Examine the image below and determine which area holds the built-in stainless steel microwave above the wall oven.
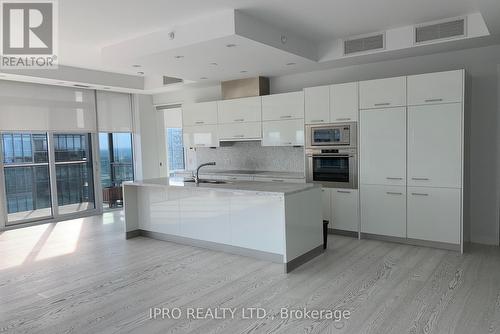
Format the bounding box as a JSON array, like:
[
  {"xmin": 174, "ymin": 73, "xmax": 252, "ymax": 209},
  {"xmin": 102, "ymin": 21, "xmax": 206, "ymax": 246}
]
[{"xmin": 306, "ymin": 122, "xmax": 357, "ymax": 148}]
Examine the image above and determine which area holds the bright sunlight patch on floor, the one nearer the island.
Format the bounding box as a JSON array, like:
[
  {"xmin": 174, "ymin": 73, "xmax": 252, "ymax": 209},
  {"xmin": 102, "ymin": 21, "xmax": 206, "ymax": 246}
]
[{"xmin": 35, "ymin": 218, "xmax": 84, "ymax": 261}]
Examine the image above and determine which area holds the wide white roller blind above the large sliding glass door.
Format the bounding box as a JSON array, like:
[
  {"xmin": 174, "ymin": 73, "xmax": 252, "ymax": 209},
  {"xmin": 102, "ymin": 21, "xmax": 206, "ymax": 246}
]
[{"xmin": 0, "ymin": 80, "xmax": 96, "ymax": 132}]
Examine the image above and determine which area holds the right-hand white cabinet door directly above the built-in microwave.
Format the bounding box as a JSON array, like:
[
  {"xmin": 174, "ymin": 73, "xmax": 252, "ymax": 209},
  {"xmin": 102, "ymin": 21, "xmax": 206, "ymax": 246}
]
[{"xmin": 330, "ymin": 82, "xmax": 359, "ymax": 122}]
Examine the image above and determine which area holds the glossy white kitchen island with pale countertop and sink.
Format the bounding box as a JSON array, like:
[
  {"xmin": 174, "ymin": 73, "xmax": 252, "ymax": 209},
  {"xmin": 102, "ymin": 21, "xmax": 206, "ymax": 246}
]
[{"xmin": 124, "ymin": 177, "xmax": 323, "ymax": 272}]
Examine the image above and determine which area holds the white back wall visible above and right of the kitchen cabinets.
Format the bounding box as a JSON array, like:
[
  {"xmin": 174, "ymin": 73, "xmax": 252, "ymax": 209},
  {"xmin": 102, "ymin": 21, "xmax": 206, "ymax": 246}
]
[{"xmin": 154, "ymin": 45, "xmax": 500, "ymax": 245}]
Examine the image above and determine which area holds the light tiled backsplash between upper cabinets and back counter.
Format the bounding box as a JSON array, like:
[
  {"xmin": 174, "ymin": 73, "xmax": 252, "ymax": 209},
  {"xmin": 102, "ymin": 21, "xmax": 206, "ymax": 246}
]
[{"xmin": 187, "ymin": 142, "xmax": 304, "ymax": 172}]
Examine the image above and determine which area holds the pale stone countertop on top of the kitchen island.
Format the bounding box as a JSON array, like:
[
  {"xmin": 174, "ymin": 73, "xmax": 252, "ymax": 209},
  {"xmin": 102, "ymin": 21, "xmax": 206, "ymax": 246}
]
[{"xmin": 124, "ymin": 177, "xmax": 319, "ymax": 195}]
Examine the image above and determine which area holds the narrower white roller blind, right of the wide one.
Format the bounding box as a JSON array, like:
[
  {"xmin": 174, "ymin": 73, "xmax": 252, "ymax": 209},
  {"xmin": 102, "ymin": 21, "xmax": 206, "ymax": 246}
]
[{"xmin": 97, "ymin": 91, "xmax": 132, "ymax": 132}]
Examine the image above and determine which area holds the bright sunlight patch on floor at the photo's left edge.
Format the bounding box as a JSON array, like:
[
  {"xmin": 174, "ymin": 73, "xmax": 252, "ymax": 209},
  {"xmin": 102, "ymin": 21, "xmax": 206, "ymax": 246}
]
[{"xmin": 0, "ymin": 224, "xmax": 49, "ymax": 270}]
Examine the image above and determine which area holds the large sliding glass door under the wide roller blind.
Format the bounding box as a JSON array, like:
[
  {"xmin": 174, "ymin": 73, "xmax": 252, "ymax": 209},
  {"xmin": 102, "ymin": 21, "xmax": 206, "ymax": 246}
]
[{"xmin": 0, "ymin": 132, "xmax": 96, "ymax": 225}]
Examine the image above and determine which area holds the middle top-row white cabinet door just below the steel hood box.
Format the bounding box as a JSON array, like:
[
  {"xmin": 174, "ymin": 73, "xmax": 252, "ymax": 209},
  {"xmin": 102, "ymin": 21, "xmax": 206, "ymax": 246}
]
[{"xmin": 218, "ymin": 96, "xmax": 262, "ymax": 123}]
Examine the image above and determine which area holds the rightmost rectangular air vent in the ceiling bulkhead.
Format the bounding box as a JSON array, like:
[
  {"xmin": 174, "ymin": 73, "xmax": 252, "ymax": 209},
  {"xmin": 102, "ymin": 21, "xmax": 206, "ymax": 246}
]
[{"xmin": 415, "ymin": 18, "xmax": 465, "ymax": 44}]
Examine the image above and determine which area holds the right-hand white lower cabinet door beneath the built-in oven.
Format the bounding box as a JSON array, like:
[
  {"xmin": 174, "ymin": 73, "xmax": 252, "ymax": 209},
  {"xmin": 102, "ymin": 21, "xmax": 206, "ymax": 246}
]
[{"xmin": 330, "ymin": 189, "xmax": 359, "ymax": 232}]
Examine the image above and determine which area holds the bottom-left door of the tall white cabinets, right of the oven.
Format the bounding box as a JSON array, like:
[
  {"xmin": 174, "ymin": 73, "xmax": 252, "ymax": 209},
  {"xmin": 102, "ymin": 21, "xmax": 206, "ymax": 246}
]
[{"xmin": 360, "ymin": 185, "xmax": 406, "ymax": 238}]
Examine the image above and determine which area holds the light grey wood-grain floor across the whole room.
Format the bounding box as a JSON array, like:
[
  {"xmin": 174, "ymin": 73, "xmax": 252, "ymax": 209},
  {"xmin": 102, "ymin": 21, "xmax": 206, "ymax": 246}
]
[{"xmin": 0, "ymin": 212, "xmax": 500, "ymax": 334}]
